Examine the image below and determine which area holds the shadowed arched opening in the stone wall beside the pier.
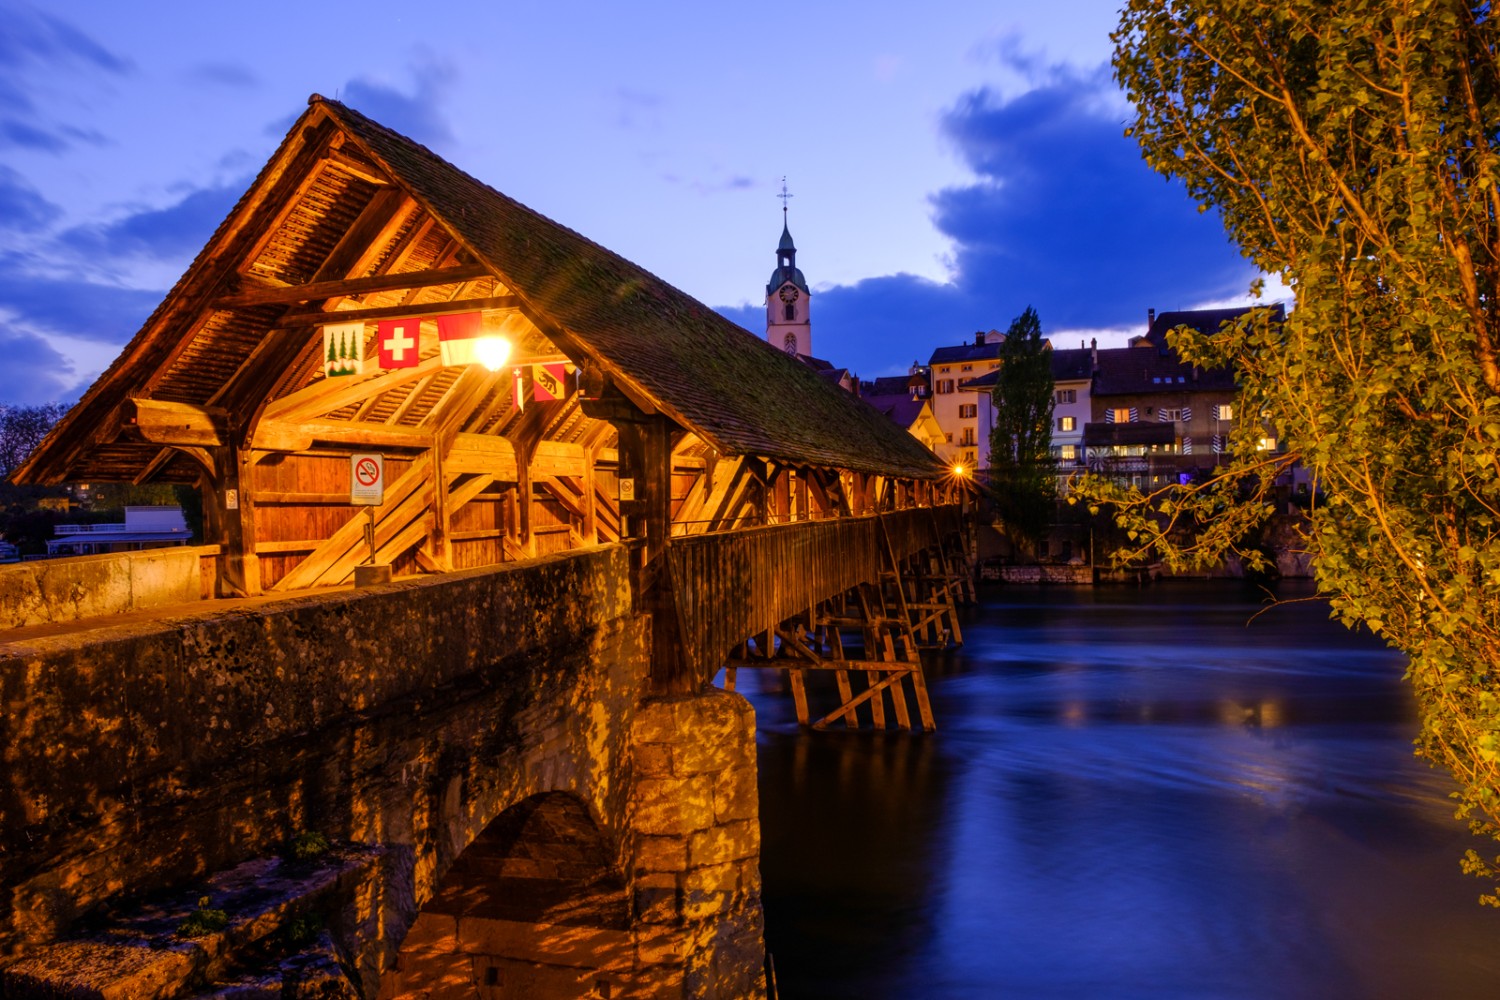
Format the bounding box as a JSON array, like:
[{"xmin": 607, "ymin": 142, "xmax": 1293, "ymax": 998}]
[{"xmin": 380, "ymin": 792, "xmax": 635, "ymax": 1000}]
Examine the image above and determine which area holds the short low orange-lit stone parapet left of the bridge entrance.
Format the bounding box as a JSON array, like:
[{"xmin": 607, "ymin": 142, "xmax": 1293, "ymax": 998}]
[{"xmin": 0, "ymin": 546, "xmax": 216, "ymax": 629}]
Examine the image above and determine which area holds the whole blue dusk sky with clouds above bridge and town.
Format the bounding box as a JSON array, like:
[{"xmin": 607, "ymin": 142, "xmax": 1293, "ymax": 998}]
[{"xmin": 0, "ymin": 0, "xmax": 1272, "ymax": 403}]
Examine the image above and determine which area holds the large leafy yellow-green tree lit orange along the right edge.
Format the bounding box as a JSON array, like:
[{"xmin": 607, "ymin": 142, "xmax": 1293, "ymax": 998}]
[{"xmin": 1116, "ymin": 0, "xmax": 1500, "ymax": 906}]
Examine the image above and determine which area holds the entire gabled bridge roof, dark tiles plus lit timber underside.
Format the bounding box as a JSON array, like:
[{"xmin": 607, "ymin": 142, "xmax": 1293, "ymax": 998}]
[{"xmin": 17, "ymin": 94, "xmax": 944, "ymax": 483}]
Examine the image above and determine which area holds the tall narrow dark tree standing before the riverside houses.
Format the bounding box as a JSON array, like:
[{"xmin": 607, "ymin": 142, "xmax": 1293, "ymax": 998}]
[{"xmin": 990, "ymin": 306, "xmax": 1056, "ymax": 544}]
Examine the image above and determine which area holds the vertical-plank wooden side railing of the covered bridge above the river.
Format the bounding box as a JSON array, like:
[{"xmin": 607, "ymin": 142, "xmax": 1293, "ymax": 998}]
[{"xmin": 666, "ymin": 505, "xmax": 960, "ymax": 678}]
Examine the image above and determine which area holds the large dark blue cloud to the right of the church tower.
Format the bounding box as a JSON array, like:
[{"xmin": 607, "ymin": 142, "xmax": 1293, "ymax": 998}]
[{"xmin": 722, "ymin": 62, "xmax": 1256, "ymax": 375}]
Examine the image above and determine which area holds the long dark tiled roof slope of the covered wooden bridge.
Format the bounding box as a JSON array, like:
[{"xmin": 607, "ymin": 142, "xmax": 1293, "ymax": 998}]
[{"xmin": 322, "ymin": 97, "xmax": 942, "ymax": 478}]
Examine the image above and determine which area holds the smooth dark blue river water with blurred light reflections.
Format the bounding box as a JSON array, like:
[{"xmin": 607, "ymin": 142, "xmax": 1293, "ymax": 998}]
[{"xmin": 741, "ymin": 585, "xmax": 1500, "ymax": 1000}]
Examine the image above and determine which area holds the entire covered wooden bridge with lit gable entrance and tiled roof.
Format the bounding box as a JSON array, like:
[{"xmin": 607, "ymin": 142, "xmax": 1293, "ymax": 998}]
[{"xmin": 17, "ymin": 96, "xmax": 968, "ymax": 726}]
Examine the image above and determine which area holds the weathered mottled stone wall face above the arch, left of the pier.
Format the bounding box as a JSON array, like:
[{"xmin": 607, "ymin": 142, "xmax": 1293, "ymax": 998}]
[{"xmin": 0, "ymin": 546, "xmax": 648, "ymax": 996}]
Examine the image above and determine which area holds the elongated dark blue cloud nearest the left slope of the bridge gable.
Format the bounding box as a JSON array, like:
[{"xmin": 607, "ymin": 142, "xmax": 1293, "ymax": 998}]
[{"xmin": 57, "ymin": 178, "xmax": 249, "ymax": 261}]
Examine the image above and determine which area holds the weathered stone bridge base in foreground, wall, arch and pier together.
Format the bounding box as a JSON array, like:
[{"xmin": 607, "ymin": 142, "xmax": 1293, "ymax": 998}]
[{"xmin": 0, "ymin": 546, "xmax": 765, "ymax": 1000}]
